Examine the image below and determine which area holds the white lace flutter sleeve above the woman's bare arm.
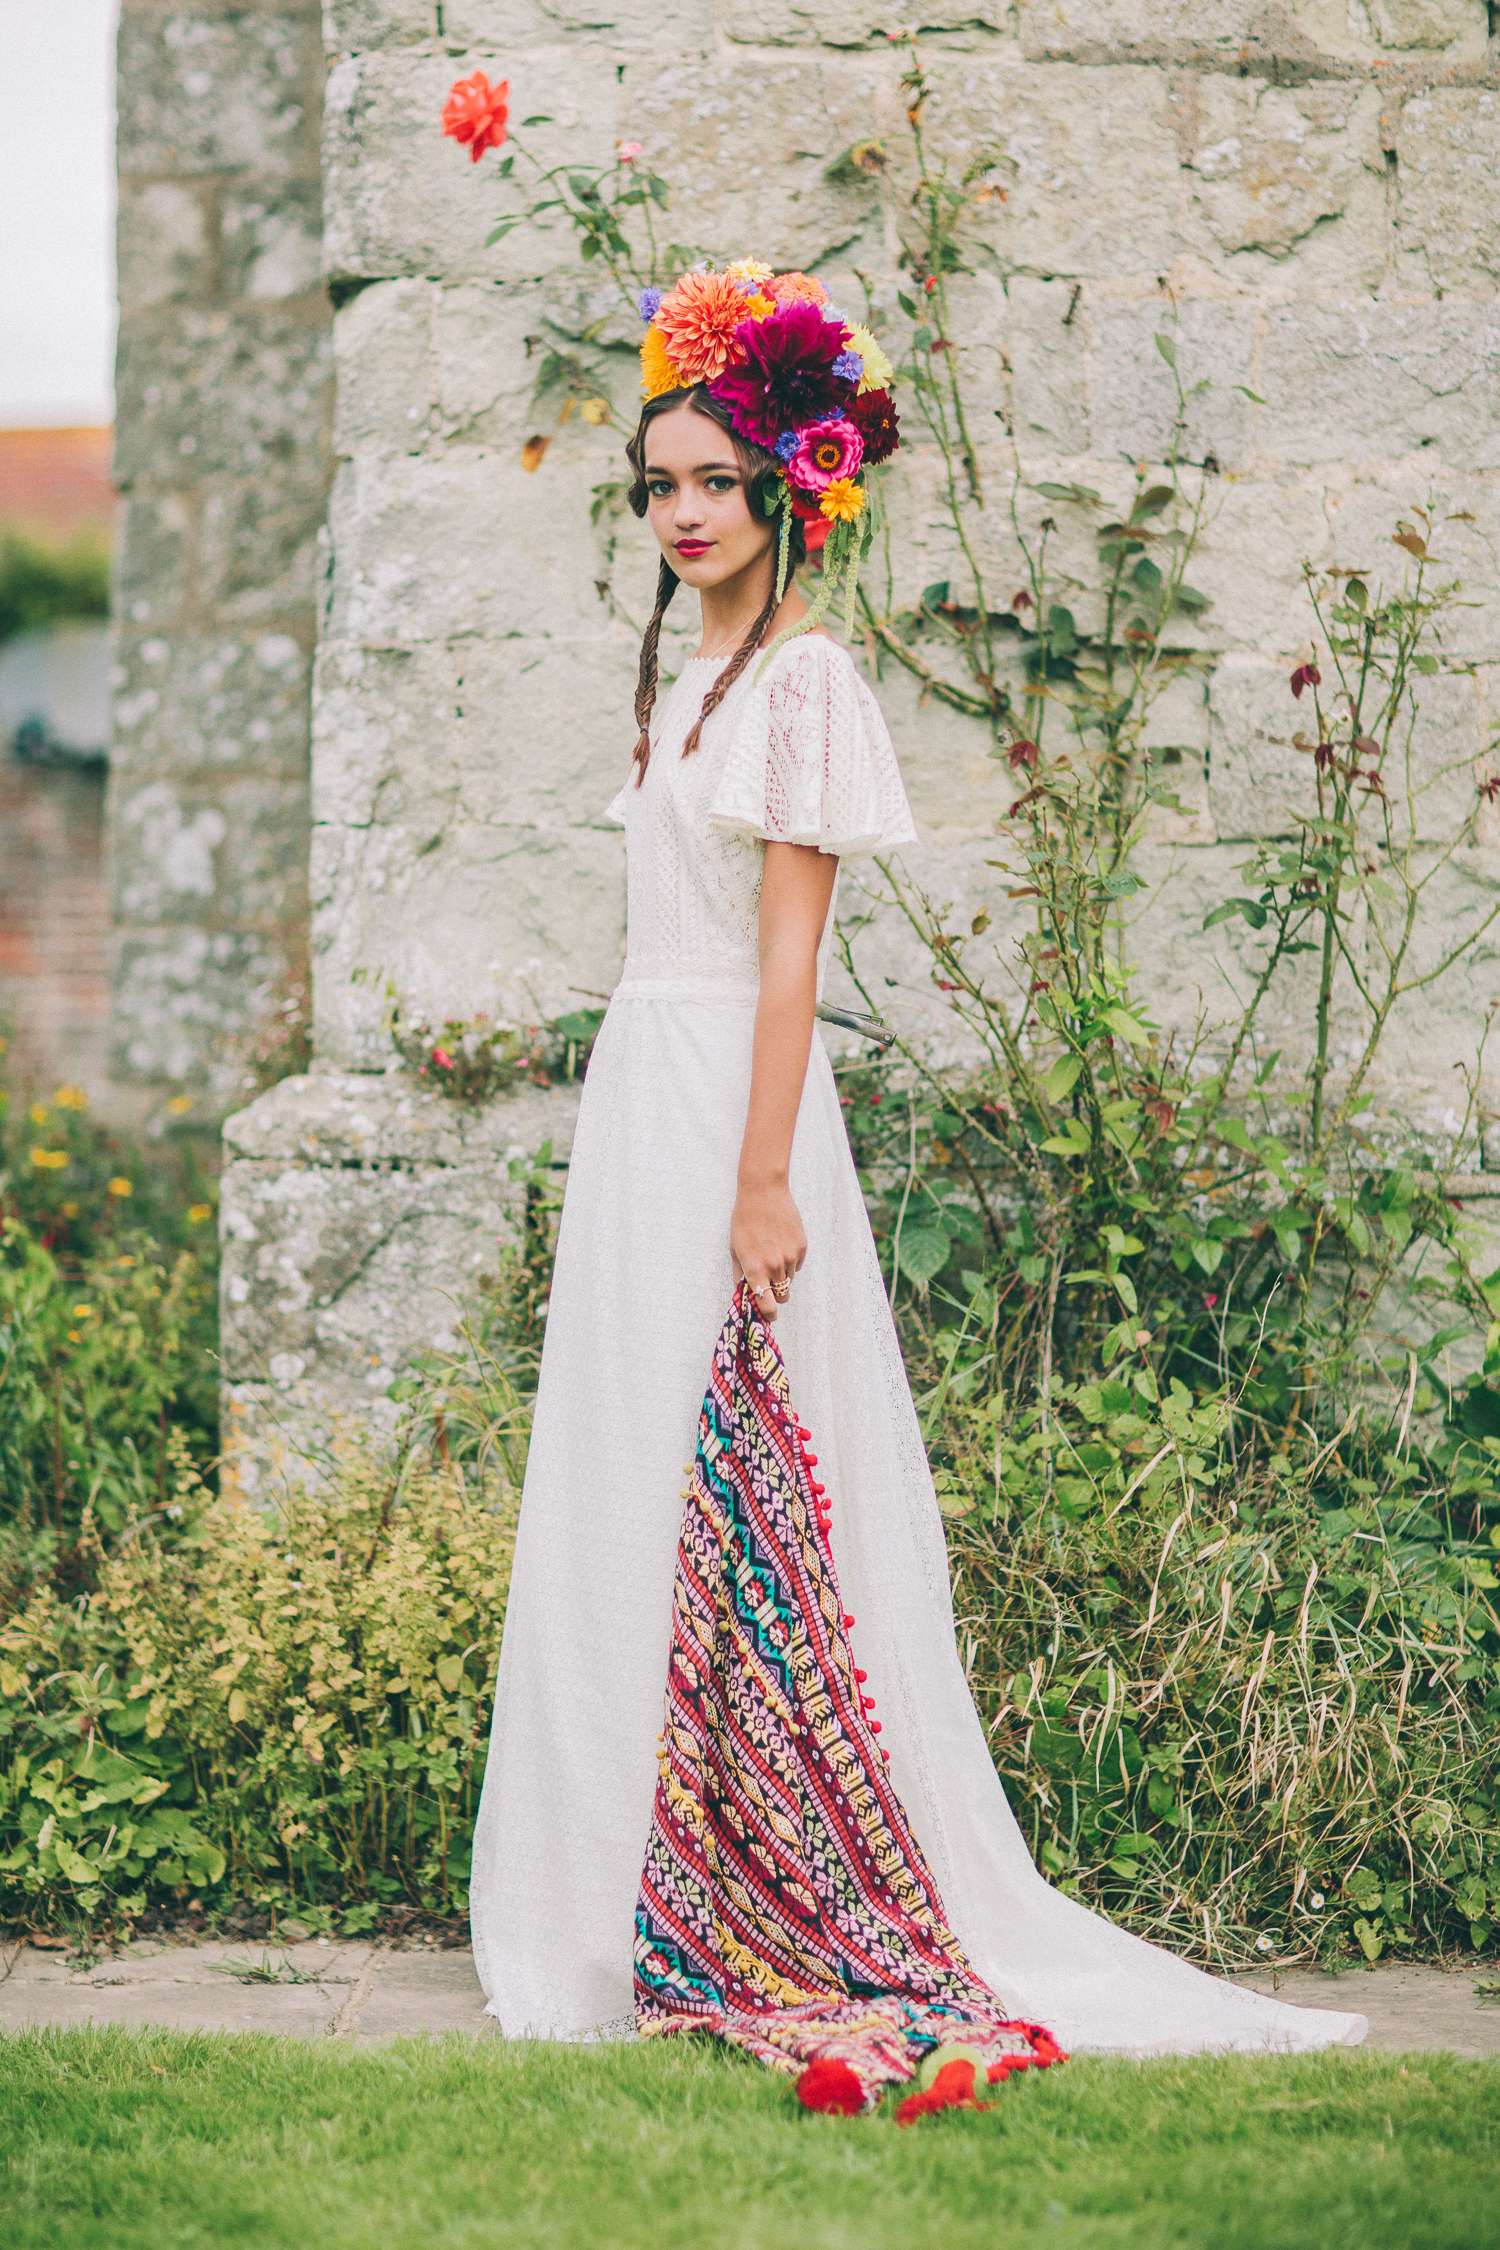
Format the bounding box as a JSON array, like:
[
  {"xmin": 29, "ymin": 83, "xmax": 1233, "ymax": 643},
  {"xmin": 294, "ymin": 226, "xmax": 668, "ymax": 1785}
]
[{"xmin": 708, "ymin": 632, "xmax": 920, "ymax": 855}]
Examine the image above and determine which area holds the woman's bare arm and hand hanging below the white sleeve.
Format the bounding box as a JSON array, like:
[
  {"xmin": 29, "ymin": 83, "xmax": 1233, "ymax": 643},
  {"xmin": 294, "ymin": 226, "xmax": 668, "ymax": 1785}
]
[{"xmin": 729, "ymin": 844, "xmax": 839, "ymax": 1321}]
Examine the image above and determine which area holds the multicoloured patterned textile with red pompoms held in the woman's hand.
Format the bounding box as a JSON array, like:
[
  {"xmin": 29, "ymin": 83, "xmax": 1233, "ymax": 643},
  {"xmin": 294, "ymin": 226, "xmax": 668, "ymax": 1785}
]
[{"xmin": 634, "ymin": 1280, "xmax": 1061, "ymax": 2111}]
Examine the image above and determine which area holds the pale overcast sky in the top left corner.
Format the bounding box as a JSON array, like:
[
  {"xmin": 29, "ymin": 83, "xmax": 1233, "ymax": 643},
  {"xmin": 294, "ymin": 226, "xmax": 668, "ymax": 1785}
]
[{"xmin": 0, "ymin": 0, "xmax": 117, "ymax": 428}]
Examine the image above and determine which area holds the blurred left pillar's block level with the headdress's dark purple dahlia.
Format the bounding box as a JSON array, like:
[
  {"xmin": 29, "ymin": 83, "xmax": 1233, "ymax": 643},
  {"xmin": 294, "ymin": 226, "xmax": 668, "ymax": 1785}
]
[{"xmin": 115, "ymin": 304, "xmax": 333, "ymax": 484}]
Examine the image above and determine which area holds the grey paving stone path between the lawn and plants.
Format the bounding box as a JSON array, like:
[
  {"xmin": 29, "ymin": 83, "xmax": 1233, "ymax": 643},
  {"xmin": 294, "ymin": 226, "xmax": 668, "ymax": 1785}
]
[{"xmin": 0, "ymin": 1937, "xmax": 1500, "ymax": 2057}]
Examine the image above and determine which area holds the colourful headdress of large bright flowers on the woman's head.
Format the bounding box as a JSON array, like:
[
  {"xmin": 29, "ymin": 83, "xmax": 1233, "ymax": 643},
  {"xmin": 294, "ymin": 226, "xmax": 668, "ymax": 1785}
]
[{"xmin": 636, "ymin": 259, "xmax": 900, "ymax": 666}]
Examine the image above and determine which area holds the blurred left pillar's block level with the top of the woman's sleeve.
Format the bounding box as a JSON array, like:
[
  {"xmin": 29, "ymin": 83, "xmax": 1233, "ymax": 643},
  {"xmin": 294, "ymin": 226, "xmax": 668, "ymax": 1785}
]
[{"xmin": 110, "ymin": 632, "xmax": 308, "ymax": 783}]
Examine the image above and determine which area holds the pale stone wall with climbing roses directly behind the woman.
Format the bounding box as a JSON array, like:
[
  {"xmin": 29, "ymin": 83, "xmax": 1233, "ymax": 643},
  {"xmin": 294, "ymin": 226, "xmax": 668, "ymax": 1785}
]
[{"xmin": 225, "ymin": 0, "xmax": 1500, "ymax": 1478}]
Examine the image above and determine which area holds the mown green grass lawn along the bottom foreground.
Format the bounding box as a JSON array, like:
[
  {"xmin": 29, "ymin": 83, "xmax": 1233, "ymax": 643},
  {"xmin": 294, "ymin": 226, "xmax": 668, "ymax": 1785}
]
[{"xmin": 0, "ymin": 2027, "xmax": 1500, "ymax": 2250}]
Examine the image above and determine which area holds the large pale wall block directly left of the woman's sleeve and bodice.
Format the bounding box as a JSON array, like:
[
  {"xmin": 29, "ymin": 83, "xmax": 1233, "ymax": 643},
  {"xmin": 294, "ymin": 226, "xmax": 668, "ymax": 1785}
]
[{"xmin": 313, "ymin": 635, "xmax": 643, "ymax": 835}]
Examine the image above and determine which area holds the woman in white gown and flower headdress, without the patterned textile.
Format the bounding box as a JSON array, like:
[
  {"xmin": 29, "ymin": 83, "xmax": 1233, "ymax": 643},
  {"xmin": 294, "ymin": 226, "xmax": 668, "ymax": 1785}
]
[{"xmin": 470, "ymin": 261, "xmax": 1365, "ymax": 2097}]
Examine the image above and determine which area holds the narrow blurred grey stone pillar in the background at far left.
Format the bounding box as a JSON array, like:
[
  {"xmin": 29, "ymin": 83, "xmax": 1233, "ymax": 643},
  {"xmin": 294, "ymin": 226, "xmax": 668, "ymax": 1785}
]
[{"xmin": 108, "ymin": 0, "xmax": 333, "ymax": 1114}]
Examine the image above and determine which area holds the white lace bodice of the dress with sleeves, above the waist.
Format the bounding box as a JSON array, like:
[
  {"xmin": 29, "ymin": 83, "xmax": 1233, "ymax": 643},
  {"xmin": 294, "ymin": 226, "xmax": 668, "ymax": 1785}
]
[{"xmin": 605, "ymin": 632, "xmax": 918, "ymax": 997}]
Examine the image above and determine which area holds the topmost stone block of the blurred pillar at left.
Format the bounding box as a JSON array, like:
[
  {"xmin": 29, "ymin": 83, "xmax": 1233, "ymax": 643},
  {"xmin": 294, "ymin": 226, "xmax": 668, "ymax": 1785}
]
[{"xmin": 117, "ymin": 5, "xmax": 324, "ymax": 178}]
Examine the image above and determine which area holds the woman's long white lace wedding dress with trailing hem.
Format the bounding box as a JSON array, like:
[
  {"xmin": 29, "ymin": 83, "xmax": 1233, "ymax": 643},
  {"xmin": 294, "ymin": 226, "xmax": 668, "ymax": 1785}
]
[{"xmin": 470, "ymin": 632, "xmax": 1365, "ymax": 2054}]
